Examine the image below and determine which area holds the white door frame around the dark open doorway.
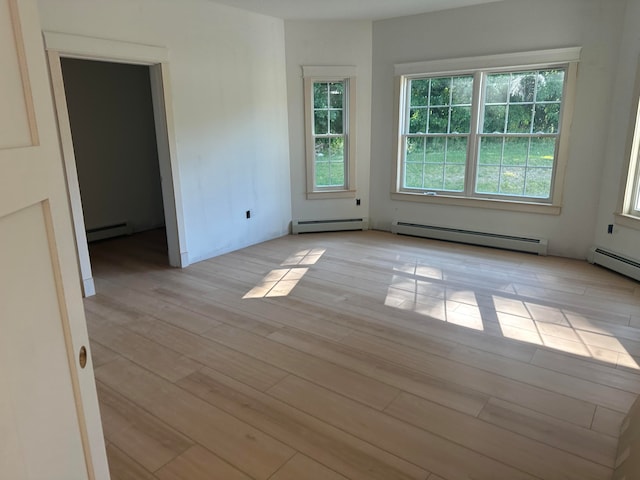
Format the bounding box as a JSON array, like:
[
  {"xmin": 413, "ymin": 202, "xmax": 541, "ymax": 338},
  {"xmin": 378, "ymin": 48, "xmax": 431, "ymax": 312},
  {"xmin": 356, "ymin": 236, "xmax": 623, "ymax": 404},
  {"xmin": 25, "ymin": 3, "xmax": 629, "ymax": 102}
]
[{"xmin": 44, "ymin": 32, "xmax": 189, "ymax": 297}]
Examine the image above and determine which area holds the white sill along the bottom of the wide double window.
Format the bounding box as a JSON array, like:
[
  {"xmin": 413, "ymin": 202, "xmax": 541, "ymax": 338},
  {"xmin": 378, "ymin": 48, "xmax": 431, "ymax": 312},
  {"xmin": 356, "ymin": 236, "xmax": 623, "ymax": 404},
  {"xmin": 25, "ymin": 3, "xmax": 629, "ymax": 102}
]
[{"xmin": 391, "ymin": 192, "xmax": 562, "ymax": 215}]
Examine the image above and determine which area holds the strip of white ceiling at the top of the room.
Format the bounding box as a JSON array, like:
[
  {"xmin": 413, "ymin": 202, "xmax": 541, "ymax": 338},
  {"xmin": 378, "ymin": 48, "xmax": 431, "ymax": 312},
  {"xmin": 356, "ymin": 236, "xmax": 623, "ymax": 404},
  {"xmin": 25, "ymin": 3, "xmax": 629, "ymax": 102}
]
[{"xmin": 208, "ymin": 0, "xmax": 503, "ymax": 20}]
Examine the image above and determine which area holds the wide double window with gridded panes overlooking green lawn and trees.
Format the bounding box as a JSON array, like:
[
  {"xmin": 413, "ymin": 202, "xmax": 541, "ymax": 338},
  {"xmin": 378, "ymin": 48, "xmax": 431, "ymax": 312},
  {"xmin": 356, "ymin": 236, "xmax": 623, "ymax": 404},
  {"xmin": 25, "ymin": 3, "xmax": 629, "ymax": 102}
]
[{"xmin": 394, "ymin": 49, "xmax": 579, "ymax": 213}]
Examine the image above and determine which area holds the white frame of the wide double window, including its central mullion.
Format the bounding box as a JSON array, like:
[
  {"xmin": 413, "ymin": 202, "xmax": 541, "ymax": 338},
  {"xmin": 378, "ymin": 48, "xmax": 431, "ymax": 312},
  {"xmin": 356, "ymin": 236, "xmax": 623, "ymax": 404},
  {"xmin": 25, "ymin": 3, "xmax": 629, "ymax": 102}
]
[{"xmin": 391, "ymin": 47, "xmax": 581, "ymax": 215}]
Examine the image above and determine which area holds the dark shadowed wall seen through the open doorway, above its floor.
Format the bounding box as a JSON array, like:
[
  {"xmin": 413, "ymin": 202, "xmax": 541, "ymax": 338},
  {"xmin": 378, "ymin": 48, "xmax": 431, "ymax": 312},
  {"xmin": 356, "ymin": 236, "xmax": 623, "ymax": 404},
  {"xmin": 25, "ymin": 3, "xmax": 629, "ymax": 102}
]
[{"xmin": 60, "ymin": 58, "xmax": 168, "ymax": 255}]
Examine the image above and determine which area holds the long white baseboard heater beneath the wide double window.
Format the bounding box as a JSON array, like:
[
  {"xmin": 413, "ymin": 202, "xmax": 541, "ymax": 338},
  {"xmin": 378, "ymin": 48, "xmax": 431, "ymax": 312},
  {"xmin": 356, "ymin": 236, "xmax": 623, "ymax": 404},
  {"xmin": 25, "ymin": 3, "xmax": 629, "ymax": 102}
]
[{"xmin": 391, "ymin": 221, "xmax": 547, "ymax": 255}]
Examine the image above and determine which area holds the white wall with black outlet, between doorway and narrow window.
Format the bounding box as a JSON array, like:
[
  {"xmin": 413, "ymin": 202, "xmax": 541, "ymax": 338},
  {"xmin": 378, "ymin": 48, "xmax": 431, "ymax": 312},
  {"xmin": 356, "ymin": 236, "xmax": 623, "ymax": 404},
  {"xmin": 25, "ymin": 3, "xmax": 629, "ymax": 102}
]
[{"xmin": 39, "ymin": 0, "xmax": 291, "ymax": 262}]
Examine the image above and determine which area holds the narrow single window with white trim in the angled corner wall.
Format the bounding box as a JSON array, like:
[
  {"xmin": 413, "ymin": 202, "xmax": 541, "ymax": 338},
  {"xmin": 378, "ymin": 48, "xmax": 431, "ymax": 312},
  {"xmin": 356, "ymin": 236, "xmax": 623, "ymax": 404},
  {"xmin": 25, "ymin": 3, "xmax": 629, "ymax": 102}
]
[{"xmin": 303, "ymin": 67, "xmax": 355, "ymax": 199}]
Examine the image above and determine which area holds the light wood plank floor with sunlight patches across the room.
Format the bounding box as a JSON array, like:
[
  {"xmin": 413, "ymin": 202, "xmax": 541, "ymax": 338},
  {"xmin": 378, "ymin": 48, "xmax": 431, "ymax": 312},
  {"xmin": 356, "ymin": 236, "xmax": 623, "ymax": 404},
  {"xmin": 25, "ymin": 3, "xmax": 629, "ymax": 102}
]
[{"xmin": 85, "ymin": 232, "xmax": 640, "ymax": 480}]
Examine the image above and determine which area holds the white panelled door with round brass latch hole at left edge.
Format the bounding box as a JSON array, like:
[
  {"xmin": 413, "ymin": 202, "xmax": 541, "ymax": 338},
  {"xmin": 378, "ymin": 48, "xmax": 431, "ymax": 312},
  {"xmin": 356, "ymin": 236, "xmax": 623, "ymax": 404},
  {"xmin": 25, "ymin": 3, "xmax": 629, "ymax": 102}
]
[{"xmin": 0, "ymin": 0, "xmax": 109, "ymax": 480}]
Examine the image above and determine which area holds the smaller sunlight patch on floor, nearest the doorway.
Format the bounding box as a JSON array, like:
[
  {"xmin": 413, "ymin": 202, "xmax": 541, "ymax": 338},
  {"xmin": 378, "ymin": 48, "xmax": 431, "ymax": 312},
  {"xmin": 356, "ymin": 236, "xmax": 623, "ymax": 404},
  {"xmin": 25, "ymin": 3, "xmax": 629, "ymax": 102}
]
[{"xmin": 242, "ymin": 248, "xmax": 326, "ymax": 299}]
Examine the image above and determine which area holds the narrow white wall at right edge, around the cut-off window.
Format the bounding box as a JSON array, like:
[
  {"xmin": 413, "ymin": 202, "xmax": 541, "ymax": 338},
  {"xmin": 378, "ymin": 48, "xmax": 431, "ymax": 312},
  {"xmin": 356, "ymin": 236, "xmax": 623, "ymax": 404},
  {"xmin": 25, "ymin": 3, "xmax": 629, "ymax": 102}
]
[{"xmin": 595, "ymin": 0, "xmax": 640, "ymax": 259}]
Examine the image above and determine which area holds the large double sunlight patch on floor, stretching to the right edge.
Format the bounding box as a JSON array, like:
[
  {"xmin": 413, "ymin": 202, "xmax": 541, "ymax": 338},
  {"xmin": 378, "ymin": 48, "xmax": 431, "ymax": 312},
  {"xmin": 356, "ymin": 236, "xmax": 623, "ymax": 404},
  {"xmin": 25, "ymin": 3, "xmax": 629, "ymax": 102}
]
[{"xmin": 384, "ymin": 272, "xmax": 640, "ymax": 369}]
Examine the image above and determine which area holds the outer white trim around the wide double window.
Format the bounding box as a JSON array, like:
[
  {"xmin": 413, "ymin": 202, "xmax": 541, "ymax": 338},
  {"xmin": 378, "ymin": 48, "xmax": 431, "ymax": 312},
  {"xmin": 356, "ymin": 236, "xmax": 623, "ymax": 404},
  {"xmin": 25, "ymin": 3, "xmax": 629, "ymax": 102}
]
[{"xmin": 391, "ymin": 47, "xmax": 582, "ymax": 215}]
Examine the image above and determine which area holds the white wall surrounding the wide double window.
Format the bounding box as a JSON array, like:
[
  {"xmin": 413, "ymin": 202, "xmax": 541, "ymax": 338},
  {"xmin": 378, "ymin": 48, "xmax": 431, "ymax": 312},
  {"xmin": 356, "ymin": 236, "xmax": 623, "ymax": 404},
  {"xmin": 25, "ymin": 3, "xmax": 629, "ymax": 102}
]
[{"xmin": 371, "ymin": 0, "xmax": 624, "ymax": 258}]
